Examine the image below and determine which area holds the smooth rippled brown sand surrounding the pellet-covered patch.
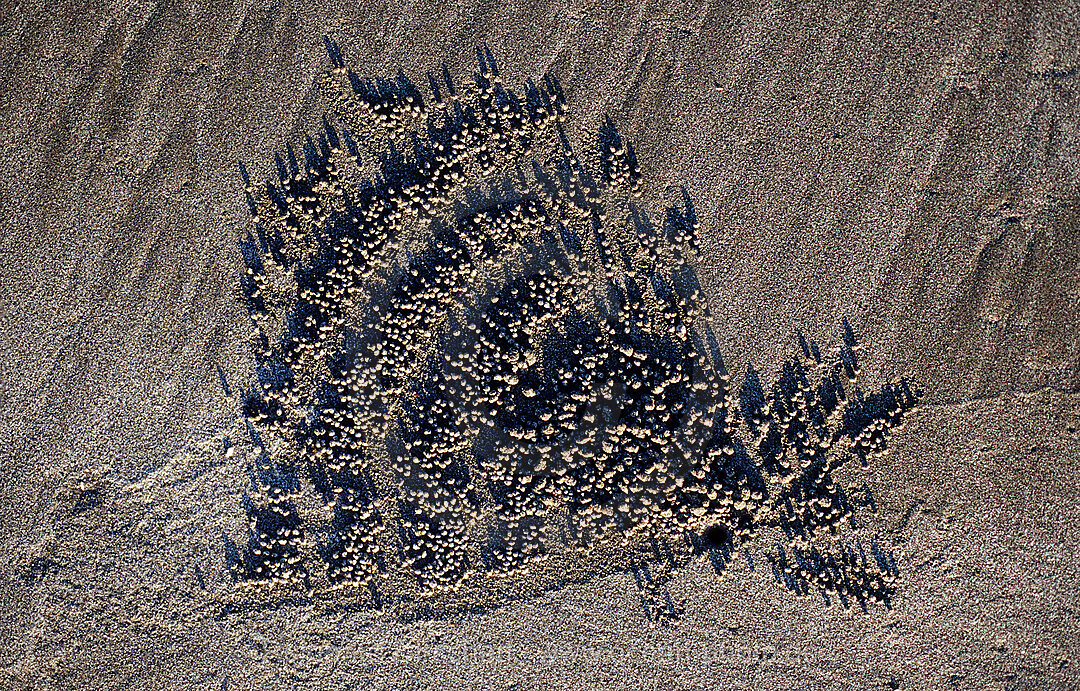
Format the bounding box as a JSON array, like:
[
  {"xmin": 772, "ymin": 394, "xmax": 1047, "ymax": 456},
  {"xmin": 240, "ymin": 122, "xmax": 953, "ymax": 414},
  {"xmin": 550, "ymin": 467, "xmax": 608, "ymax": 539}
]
[{"xmin": 0, "ymin": 1, "xmax": 1080, "ymax": 689}]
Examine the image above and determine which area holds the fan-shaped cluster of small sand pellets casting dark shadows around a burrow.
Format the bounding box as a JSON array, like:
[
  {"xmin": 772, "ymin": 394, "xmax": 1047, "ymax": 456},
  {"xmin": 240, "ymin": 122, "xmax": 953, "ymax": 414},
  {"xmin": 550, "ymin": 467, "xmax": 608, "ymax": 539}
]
[{"xmin": 227, "ymin": 41, "xmax": 918, "ymax": 619}]
